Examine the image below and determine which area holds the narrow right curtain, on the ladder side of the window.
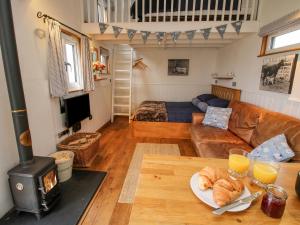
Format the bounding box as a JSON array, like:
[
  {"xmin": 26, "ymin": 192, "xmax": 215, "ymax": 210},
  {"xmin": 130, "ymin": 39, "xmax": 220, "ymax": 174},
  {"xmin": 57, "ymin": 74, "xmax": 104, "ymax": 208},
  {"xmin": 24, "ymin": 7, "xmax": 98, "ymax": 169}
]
[{"xmin": 80, "ymin": 36, "xmax": 95, "ymax": 91}]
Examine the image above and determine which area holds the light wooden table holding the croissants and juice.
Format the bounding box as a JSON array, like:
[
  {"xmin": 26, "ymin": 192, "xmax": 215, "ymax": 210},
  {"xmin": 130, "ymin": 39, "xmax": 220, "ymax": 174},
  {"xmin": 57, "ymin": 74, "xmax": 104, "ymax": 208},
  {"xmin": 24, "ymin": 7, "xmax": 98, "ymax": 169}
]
[{"xmin": 129, "ymin": 155, "xmax": 300, "ymax": 225}]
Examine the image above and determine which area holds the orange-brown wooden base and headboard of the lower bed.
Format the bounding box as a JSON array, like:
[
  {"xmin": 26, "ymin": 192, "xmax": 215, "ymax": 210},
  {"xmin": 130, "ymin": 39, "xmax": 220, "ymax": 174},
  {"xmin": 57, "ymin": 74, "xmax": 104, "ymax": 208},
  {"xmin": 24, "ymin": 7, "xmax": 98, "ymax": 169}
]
[{"xmin": 131, "ymin": 85, "xmax": 241, "ymax": 139}]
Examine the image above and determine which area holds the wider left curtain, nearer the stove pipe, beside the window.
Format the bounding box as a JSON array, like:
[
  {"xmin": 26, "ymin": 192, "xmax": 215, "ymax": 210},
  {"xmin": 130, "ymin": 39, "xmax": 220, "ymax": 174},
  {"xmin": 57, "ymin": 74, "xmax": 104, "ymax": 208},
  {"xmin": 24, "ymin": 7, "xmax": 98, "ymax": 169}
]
[{"xmin": 48, "ymin": 19, "xmax": 68, "ymax": 97}]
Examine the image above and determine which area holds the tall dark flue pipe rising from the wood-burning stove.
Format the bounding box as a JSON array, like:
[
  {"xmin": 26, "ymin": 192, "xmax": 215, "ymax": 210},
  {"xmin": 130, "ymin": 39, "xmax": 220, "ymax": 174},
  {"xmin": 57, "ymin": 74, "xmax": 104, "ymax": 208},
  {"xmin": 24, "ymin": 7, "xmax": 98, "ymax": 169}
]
[{"xmin": 0, "ymin": 0, "xmax": 33, "ymax": 165}]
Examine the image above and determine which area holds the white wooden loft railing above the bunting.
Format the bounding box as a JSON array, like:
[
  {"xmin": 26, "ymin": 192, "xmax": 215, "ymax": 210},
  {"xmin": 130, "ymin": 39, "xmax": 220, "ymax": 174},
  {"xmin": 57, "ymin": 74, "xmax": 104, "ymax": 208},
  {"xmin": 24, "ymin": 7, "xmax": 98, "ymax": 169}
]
[{"xmin": 82, "ymin": 0, "xmax": 259, "ymax": 23}]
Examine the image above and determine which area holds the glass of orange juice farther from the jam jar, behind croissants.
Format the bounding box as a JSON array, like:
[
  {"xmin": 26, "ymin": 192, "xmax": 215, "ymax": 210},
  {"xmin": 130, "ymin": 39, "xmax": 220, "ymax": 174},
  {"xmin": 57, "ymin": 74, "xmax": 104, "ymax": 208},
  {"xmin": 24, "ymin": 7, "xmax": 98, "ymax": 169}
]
[{"xmin": 228, "ymin": 148, "xmax": 250, "ymax": 178}]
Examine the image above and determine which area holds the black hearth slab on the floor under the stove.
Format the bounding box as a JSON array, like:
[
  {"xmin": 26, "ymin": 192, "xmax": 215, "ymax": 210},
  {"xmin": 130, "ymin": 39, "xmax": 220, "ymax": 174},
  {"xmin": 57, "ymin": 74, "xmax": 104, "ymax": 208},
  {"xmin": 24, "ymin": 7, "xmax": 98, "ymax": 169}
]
[{"xmin": 0, "ymin": 170, "xmax": 106, "ymax": 225}]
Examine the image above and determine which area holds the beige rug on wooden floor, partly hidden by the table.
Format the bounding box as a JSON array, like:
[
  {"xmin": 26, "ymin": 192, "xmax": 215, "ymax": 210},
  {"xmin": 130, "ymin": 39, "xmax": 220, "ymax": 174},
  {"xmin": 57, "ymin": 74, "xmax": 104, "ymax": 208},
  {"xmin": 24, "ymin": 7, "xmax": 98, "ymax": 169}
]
[{"xmin": 118, "ymin": 143, "xmax": 180, "ymax": 203}]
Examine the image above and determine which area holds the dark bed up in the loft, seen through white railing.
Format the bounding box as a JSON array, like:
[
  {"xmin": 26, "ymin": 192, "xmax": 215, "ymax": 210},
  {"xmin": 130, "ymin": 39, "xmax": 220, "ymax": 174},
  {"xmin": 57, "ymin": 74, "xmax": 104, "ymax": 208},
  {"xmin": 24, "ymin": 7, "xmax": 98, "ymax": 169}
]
[{"xmin": 130, "ymin": 0, "xmax": 252, "ymax": 22}]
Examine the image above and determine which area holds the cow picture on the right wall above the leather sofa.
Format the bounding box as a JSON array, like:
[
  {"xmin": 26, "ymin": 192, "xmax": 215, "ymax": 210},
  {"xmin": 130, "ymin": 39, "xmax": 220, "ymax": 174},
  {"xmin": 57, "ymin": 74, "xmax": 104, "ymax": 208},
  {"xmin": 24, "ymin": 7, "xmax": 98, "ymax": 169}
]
[{"xmin": 259, "ymin": 54, "xmax": 298, "ymax": 94}]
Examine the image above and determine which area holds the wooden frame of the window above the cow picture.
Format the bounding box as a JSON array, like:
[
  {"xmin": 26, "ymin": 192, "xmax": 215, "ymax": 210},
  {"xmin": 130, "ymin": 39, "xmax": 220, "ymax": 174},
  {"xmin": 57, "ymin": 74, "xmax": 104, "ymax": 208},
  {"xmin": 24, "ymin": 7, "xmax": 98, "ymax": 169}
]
[{"xmin": 259, "ymin": 24, "xmax": 300, "ymax": 57}]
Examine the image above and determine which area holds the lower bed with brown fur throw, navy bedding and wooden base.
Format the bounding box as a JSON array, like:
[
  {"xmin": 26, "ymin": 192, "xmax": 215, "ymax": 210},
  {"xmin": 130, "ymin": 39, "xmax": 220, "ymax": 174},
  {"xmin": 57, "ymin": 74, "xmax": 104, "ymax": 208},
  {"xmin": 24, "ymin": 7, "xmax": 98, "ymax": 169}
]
[{"xmin": 131, "ymin": 85, "xmax": 241, "ymax": 139}]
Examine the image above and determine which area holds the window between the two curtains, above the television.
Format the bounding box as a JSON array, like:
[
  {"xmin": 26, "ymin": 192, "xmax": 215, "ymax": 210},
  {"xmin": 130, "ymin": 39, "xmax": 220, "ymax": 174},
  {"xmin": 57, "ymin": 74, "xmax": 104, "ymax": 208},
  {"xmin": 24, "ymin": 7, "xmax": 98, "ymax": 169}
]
[{"xmin": 62, "ymin": 33, "xmax": 83, "ymax": 91}]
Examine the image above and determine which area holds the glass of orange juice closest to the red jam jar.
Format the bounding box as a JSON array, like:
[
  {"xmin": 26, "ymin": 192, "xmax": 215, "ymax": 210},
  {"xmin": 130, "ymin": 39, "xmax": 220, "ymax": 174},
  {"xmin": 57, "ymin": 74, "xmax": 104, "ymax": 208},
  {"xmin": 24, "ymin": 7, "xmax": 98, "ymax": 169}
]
[{"xmin": 252, "ymin": 160, "xmax": 280, "ymax": 187}]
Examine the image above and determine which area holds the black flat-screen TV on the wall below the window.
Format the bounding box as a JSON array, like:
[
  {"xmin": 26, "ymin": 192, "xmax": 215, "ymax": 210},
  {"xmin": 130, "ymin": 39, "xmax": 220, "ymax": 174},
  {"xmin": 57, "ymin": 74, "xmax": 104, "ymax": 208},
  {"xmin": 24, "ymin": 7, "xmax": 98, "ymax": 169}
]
[{"xmin": 64, "ymin": 94, "xmax": 91, "ymax": 127}]
